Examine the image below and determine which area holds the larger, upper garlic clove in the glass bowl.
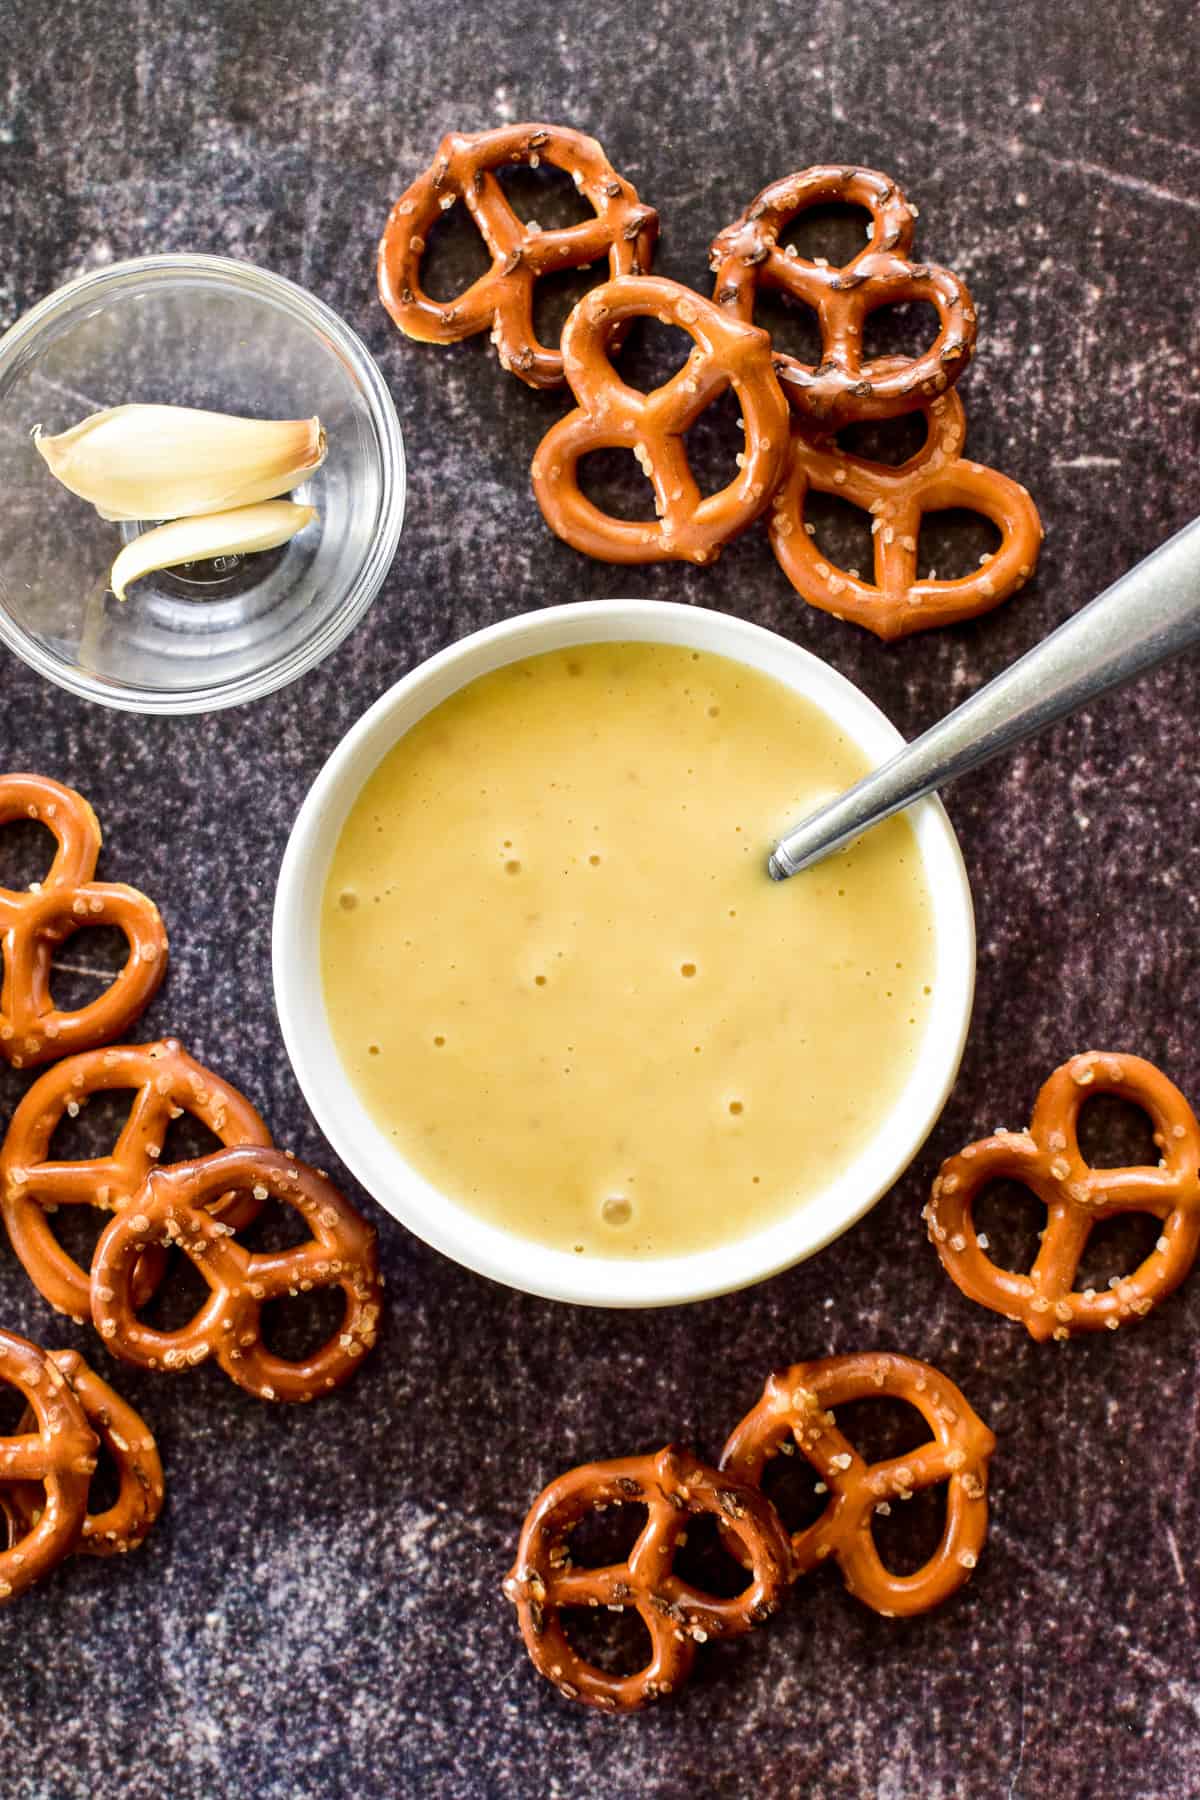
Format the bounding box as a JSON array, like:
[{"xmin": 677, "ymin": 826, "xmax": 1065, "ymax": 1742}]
[{"xmin": 32, "ymin": 405, "xmax": 326, "ymax": 518}]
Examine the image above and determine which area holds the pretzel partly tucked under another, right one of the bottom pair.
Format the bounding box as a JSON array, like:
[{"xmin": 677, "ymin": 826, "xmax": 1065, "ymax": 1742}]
[{"xmin": 721, "ymin": 1350, "xmax": 995, "ymax": 1618}]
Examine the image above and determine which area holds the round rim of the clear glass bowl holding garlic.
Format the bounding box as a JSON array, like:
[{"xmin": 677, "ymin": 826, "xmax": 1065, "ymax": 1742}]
[{"xmin": 0, "ymin": 250, "xmax": 407, "ymax": 715}]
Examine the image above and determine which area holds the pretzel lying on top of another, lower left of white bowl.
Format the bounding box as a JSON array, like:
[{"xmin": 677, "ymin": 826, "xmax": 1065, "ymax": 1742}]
[{"xmin": 92, "ymin": 1148, "xmax": 383, "ymax": 1400}]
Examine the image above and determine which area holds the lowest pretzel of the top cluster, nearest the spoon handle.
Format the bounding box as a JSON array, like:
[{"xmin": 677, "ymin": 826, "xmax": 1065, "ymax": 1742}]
[{"xmin": 770, "ymin": 358, "xmax": 1042, "ymax": 639}]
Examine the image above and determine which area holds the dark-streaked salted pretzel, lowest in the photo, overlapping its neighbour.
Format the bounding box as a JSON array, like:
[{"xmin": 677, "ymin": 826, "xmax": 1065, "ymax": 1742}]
[{"xmin": 504, "ymin": 1445, "xmax": 788, "ymax": 1712}]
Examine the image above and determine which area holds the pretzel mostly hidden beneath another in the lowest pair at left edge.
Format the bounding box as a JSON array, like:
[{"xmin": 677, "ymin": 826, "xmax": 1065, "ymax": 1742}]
[{"xmin": 0, "ymin": 1350, "xmax": 164, "ymax": 1557}]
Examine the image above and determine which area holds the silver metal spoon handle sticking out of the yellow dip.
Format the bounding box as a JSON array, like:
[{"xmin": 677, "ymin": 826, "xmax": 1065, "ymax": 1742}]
[{"xmin": 766, "ymin": 518, "xmax": 1200, "ymax": 882}]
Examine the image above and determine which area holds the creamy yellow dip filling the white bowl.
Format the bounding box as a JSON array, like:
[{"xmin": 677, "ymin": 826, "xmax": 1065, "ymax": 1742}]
[{"xmin": 322, "ymin": 644, "xmax": 934, "ymax": 1256}]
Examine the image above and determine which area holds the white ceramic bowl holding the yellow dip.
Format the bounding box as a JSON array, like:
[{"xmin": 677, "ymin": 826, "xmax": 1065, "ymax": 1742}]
[{"xmin": 273, "ymin": 599, "xmax": 975, "ymax": 1307}]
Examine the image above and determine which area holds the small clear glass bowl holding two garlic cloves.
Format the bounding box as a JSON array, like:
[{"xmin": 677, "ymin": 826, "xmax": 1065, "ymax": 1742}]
[{"xmin": 0, "ymin": 256, "xmax": 405, "ymax": 713}]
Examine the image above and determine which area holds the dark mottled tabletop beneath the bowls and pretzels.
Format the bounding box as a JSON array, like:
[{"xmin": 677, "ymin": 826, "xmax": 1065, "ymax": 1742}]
[{"xmin": 0, "ymin": 0, "xmax": 1200, "ymax": 1800}]
